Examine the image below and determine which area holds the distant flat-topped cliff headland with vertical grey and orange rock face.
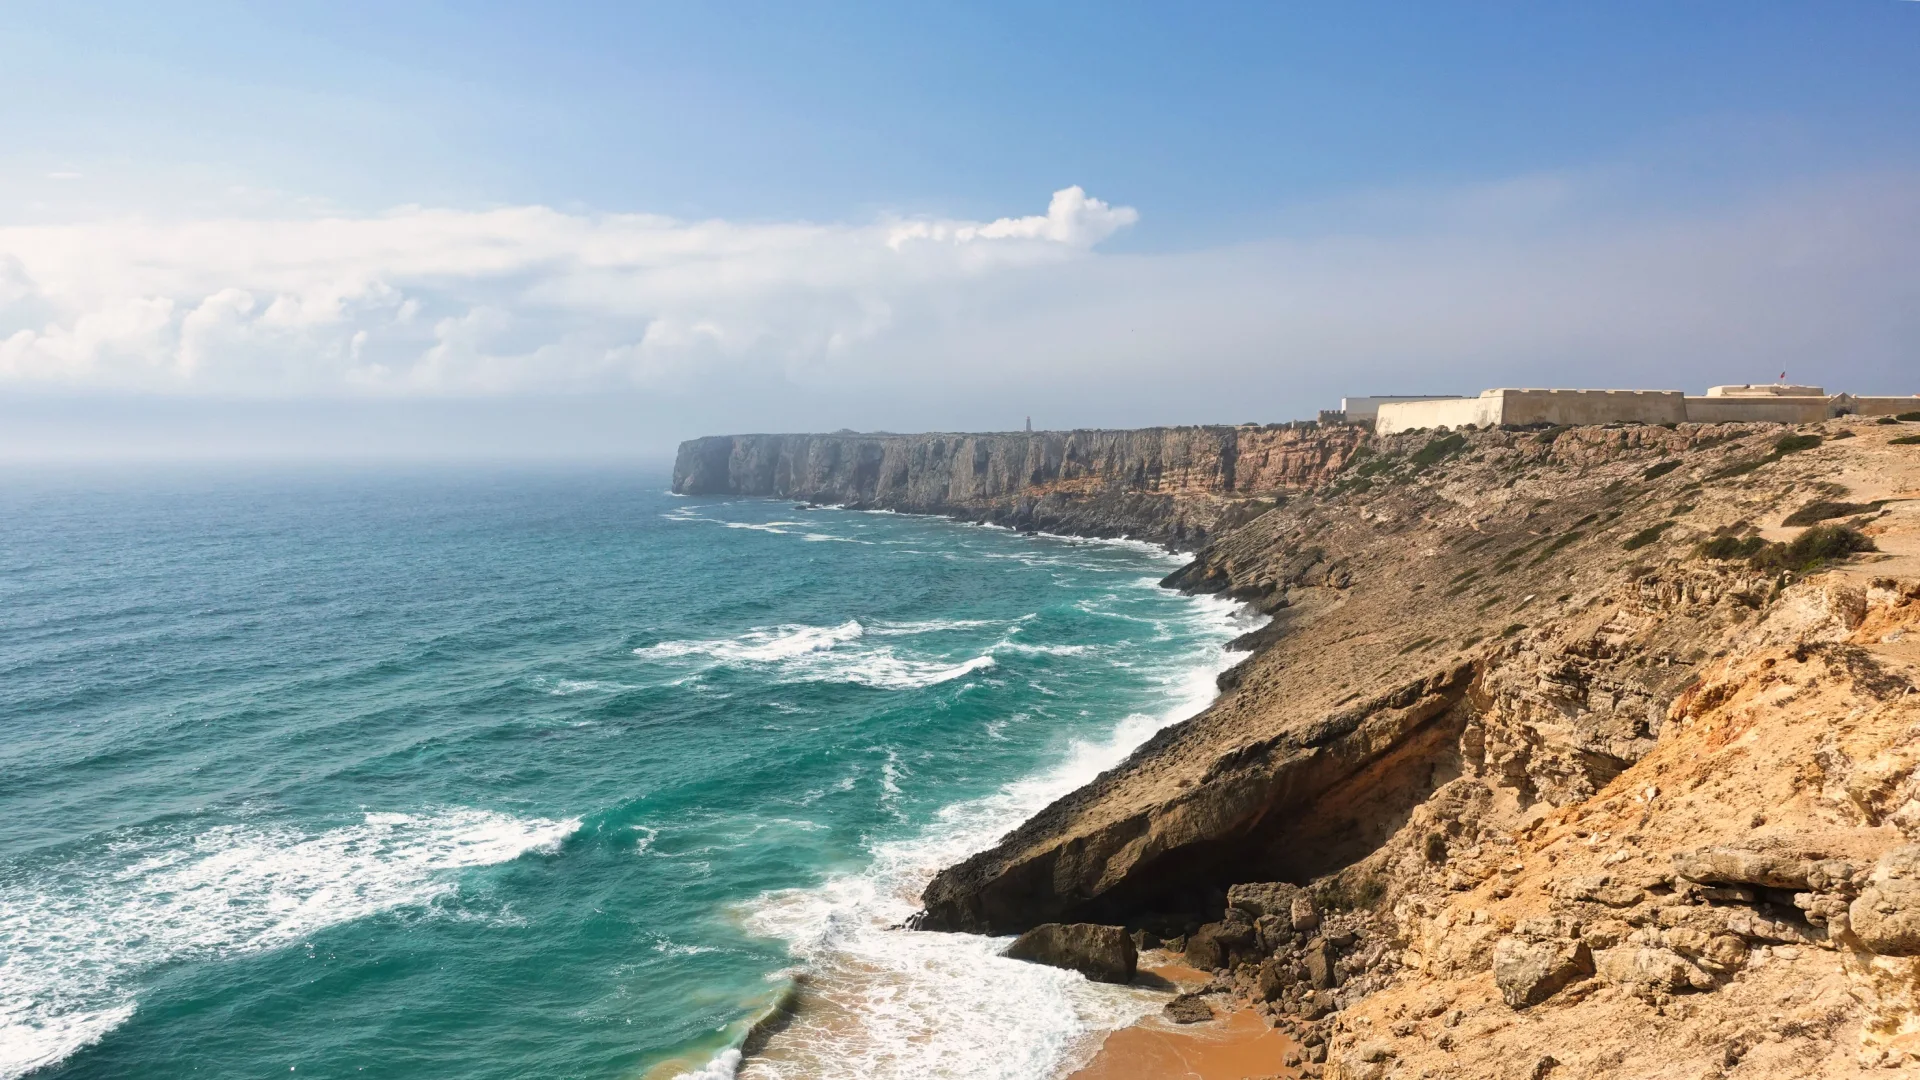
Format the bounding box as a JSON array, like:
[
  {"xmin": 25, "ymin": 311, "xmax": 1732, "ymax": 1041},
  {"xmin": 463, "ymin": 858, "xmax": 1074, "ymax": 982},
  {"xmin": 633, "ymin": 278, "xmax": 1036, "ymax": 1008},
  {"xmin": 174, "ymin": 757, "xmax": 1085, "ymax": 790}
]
[{"xmin": 674, "ymin": 427, "xmax": 1367, "ymax": 548}]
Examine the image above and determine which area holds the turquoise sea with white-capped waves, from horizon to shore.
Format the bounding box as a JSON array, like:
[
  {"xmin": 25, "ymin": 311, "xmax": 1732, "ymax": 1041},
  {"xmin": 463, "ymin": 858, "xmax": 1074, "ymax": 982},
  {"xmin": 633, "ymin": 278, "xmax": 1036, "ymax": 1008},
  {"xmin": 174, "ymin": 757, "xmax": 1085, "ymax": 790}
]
[{"xmin": 0, "ymin": 469, "xmax": 1246, "ymax": 1080}]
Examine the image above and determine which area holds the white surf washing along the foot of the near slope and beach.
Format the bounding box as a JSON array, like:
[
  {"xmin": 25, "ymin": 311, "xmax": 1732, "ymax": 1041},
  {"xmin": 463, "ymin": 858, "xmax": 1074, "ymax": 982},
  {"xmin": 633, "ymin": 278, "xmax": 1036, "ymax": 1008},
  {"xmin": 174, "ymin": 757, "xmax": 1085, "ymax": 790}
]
[{"xmin": 733, "ymin": 598, "xmax": 1244, "ymax": 1080}]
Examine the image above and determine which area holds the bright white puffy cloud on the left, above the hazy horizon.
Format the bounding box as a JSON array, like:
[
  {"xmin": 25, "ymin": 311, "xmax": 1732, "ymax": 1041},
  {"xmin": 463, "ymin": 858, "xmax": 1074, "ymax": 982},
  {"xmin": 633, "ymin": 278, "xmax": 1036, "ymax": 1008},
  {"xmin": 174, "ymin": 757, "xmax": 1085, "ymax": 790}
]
[{"xmin": 0, "ymin": 186, "xmax": 1137, "ymax": 394}]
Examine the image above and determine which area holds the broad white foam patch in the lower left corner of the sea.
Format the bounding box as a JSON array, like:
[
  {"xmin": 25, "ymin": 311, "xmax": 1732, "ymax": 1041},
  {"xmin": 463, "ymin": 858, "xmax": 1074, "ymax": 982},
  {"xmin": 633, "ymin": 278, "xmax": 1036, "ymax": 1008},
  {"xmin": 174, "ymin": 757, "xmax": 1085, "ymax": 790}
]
[{"xmin": 0, "ymin": 809, "xmax": 580, "ymax": 1078}]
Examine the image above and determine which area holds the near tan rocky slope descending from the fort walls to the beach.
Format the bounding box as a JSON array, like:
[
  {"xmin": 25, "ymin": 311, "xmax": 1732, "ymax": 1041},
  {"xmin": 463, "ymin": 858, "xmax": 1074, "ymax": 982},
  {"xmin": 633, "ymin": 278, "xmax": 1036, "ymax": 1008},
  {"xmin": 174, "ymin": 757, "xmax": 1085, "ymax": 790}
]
[{"xmin": 902, "ymin": 419, "xmax": 1920, "ymax": 1078}]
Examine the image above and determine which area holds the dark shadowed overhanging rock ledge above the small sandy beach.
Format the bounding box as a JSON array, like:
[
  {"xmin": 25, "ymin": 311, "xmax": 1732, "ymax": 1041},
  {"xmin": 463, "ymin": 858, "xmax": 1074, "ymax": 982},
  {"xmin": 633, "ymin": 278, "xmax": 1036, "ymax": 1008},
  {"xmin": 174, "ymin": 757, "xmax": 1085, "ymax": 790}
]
[{"xmin": 916, "ymin": 665, "xmax": 1473, "ymax": 934}]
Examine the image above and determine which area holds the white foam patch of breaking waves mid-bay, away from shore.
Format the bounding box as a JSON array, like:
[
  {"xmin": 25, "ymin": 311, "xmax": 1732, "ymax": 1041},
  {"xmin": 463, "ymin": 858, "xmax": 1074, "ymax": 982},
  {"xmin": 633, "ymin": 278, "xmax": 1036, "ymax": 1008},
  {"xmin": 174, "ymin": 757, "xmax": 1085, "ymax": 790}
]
[{"xmin": 634, "ymin": 619, "xmax": 993, "ymax": 690}]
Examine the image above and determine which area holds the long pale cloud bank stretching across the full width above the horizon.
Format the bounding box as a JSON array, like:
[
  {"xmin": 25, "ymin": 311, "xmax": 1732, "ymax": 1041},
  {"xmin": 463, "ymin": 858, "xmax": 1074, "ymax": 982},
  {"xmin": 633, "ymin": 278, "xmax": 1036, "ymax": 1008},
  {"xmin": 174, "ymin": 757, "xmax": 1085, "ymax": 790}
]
[{"xmin": 0, "ymin": 173, "xmax": 1920, "ymax": 453}]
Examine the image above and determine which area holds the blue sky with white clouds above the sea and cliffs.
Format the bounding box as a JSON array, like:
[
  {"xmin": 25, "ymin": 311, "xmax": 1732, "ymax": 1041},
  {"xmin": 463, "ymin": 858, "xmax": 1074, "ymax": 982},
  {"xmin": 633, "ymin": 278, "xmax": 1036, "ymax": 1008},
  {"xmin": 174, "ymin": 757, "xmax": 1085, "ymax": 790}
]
[{"xmin": 0, "ymin": 0, "xmax": 1920, "ymax": 461}]
